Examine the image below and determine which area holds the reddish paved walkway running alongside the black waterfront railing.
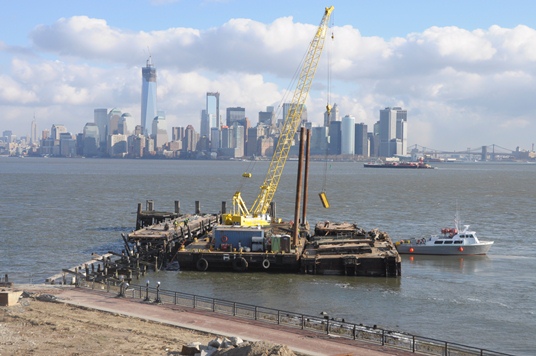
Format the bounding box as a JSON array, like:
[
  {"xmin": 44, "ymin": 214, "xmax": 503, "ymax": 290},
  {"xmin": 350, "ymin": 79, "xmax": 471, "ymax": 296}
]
[{"xmin": 25, "ymin": 285, "xmax": 413, "ymax": 356}]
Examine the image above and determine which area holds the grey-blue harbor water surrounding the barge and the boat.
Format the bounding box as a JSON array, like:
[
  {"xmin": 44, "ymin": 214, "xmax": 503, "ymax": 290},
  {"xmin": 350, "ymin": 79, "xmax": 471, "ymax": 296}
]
[{"xmin": 0, "ymin": 157, "xmax": 536, "ymax": 355}]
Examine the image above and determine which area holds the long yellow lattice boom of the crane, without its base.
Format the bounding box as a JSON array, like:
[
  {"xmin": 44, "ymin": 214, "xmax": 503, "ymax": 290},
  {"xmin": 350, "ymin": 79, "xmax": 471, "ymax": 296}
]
[{"xmin": 249, "ymin": 6, "xmax": 334, "ymax": 216}]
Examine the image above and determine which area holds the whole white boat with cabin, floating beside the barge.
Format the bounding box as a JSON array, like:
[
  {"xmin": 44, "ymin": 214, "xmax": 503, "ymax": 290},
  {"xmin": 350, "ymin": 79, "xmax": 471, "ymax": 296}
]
[{"xmin": 395, "ymin": 218, "xmax": 493, "ymax": 255}]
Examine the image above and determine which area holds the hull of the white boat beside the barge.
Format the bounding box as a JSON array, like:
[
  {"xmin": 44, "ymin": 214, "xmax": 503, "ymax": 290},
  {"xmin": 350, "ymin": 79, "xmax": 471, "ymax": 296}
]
[{"xmin": 395, "ymin": 241, "xmax": 493, "ymax": 255}]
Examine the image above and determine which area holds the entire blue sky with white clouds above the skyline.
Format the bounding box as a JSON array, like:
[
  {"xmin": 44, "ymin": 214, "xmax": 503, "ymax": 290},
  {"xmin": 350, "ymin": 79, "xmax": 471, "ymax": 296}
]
[{"xmin": 0, "ymin": 0, "xmax": 536, "ymax": 151}]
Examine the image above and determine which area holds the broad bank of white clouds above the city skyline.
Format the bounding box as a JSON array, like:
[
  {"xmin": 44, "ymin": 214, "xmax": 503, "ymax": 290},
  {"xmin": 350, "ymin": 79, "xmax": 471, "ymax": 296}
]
[{"xmin": 0, "ymin": 16, "xmax": 536, "ymax": 149}]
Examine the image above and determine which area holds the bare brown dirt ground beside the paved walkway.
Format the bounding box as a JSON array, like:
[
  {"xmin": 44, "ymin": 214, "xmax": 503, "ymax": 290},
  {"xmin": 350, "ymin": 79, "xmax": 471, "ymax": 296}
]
[{"xmin": 0, "ymin": 298, "xmax": 215, "ymax": 355}]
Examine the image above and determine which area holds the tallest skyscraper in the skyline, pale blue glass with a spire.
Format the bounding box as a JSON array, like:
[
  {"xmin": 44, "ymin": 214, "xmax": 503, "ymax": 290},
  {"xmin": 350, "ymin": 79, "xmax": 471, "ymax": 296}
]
[{"xmin": 141, "ymin": 57, "xmax": 157, "ymax": 136}]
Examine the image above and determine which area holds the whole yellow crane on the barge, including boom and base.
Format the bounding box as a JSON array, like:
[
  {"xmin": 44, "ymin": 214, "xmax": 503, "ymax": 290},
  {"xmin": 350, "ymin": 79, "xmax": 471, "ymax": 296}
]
[{"xmin": 225, "ymin": 6, "xmax": 334, "ymax": 226}]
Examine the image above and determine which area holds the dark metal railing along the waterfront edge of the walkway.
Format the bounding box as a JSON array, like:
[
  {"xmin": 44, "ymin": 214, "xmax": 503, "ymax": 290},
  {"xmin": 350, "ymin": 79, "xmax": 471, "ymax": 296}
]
[{"xmin": 80, "ymin": 282, "xmax": 510, "ymax": 356}]
